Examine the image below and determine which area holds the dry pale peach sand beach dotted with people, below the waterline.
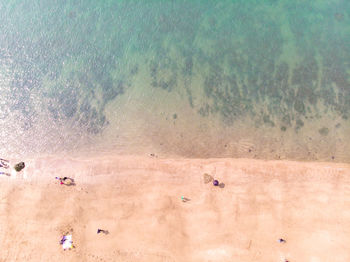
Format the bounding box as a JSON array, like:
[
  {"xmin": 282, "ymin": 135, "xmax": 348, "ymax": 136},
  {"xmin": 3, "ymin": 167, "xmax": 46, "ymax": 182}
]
[{"xmin": 0, "ymin": 156, "xmax": 350, "ymax": 262}]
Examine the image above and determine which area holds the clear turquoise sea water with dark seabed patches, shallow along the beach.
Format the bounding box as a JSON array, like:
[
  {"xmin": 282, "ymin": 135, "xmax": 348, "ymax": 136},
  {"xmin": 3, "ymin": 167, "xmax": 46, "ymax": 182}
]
[{"xmin": 0, "ymin": 0, "xmax": 350, "ymax": 162}]
